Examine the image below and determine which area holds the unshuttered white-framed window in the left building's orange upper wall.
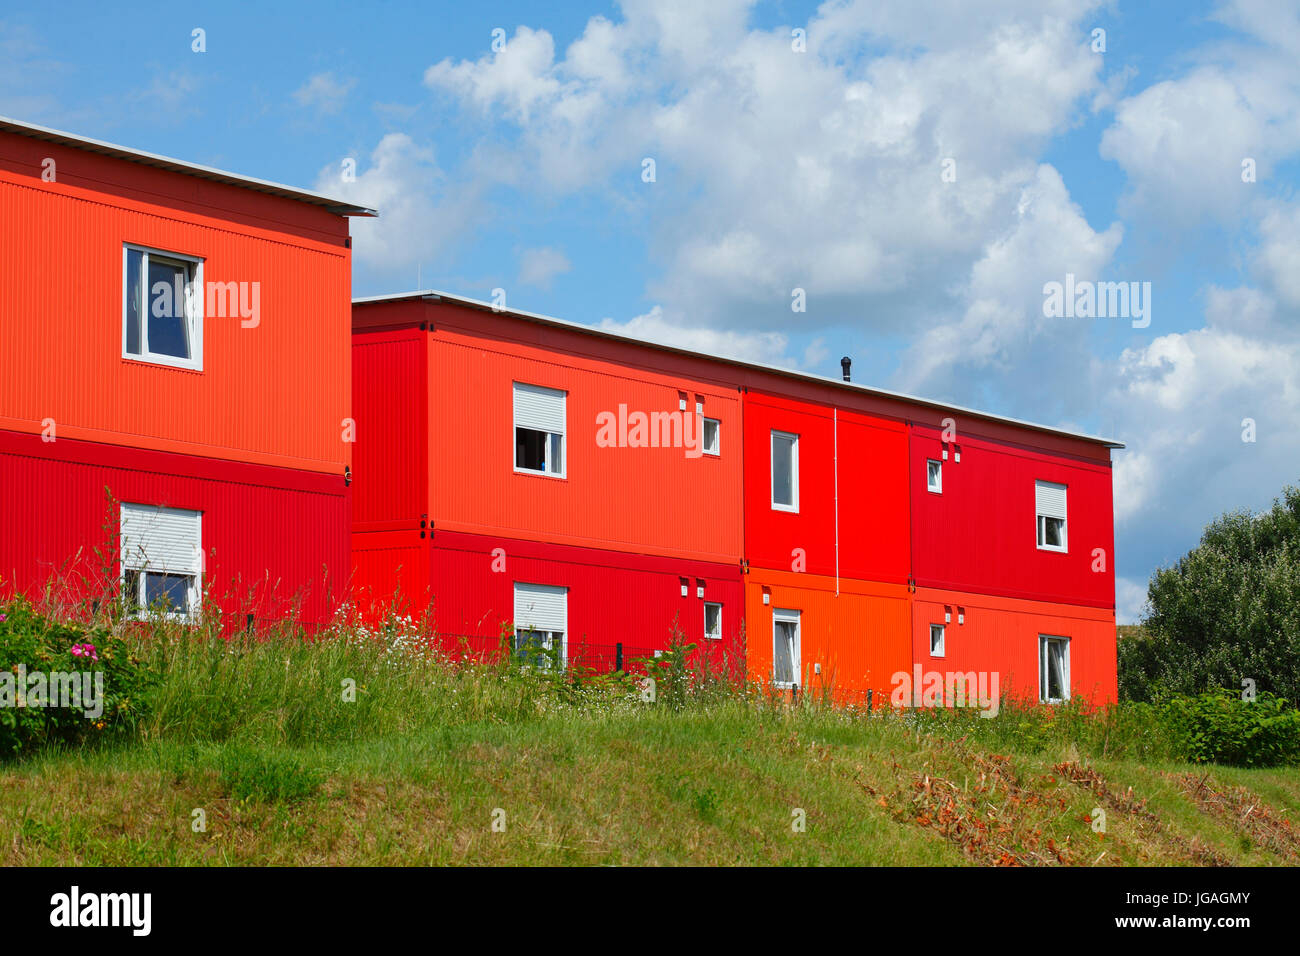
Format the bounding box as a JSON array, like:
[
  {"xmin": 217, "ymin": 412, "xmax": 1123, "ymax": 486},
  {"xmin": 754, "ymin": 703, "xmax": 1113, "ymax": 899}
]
[{"xmin": 122, "ymin": 246, "xmax": 203, "ymax": 371}]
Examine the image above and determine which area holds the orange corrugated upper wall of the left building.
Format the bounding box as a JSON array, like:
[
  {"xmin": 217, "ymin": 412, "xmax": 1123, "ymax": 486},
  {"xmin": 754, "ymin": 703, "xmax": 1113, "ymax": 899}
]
[{"xmin": 0, "ymin": 134, "xmax": 351, "ymax": 475}]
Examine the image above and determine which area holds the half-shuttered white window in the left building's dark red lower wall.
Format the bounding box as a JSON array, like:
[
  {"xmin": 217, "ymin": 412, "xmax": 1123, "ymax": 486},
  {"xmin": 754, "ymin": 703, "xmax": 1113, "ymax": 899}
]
[{"xmin": 120, "ymin": 503, "xmax": 203, "ymax": 620}]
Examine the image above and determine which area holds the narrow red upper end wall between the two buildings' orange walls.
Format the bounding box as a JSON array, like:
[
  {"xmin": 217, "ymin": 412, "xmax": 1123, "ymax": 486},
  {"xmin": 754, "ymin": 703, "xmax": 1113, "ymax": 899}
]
[{"xmin": 352, "ymin": 329, "xmax": 428, "ymax": 531}]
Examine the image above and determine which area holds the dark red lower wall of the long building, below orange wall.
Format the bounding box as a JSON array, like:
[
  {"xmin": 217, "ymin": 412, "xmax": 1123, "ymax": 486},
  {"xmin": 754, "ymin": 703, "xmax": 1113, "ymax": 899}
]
[{"xmin": 430, "ymin": 531, "xmax": 744, "ymax": 670}]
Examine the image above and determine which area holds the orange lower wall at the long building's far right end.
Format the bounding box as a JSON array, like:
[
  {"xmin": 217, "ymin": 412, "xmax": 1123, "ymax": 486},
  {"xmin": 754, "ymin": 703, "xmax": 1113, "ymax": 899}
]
[{"xmin": 911, "ymin": 588, "xmax": 1117, "ymax": 704}]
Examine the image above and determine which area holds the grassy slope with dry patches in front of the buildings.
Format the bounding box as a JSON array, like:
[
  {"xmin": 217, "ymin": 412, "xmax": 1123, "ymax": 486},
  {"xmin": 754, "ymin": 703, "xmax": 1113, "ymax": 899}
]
[{"xmin": 0, "ymin": 613, "xmax": 1300, "ymax": 865}]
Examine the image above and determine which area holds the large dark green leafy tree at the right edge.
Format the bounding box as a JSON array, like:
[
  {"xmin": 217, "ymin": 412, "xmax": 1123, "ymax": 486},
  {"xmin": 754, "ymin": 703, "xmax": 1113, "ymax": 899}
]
[{"xmin": 1119, "ymin": 486, "xmax": 1300, "ymax": 705}]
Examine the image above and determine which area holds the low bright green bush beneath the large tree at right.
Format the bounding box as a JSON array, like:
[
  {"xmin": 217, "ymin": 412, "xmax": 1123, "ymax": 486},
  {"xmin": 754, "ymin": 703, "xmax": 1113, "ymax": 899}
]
[{"xmin": 1161, "ymin": 689, "xmax": 1300, "ymax": 767}]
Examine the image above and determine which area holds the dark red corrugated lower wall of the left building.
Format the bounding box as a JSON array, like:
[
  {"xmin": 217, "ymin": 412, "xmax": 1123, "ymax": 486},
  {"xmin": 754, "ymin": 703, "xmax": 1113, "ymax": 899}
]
[{"xmin": 0, "ymin": 432, "xmax": 350, "ymax": 624}]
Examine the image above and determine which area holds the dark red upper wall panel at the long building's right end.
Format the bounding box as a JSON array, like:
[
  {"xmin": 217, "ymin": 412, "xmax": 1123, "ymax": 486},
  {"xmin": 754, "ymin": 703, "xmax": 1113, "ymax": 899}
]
[{"xmin": 910, "ymin": 425, "xmax": 1115, "ymax": 609}]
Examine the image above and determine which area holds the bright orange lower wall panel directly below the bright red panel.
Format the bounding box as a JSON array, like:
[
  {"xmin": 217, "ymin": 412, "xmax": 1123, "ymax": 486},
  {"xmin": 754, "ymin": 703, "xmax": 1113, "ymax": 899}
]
[{"xmin": 745, "ymin": 568, "xmax": 911, "ymax": 704}]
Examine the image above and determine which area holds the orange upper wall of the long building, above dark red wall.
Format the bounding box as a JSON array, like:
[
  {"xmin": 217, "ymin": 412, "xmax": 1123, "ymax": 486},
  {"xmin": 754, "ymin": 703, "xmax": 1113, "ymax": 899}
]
[{"xmin": 428, "ymin": 306, "xmax": 742, "ymax": 564}]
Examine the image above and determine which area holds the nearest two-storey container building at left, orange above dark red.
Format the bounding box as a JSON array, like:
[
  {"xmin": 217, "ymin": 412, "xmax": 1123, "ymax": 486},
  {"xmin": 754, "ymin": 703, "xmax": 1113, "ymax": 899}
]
[{"xmin": 0, "ymin": 120, "xmax": 371, "ymax": 624}]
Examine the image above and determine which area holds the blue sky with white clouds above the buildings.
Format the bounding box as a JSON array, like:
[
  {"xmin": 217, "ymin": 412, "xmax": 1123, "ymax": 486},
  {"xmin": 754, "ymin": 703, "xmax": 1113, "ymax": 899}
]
[{"xmin": 0, "ymin": 0, "xmax": 1300, "ymax": 620}]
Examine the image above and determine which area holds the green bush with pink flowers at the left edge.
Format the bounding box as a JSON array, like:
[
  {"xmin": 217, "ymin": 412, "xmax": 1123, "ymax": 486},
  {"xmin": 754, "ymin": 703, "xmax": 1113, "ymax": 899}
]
[{"xmin": 0, "ymin": 601, "xmax": 156, "ymax": 760}]
